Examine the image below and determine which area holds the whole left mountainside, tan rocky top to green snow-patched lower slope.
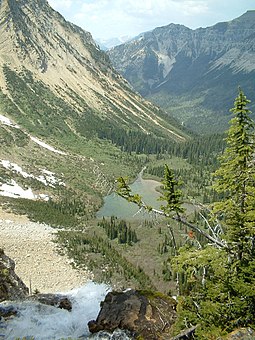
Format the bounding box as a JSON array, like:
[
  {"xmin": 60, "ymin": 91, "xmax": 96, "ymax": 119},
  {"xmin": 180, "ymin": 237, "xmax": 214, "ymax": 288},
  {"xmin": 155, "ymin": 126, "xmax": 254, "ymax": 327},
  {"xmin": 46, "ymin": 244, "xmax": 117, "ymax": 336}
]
[{"xmin": 0, "ymin": 0, "xmax": 187, "ymax": 215}]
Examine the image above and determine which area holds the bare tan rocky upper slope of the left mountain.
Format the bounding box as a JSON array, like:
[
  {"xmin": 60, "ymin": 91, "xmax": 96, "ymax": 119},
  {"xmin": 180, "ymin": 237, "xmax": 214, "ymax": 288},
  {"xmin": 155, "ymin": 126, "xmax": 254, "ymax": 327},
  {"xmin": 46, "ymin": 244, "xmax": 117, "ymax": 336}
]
[{"xmin": 0, "ymin": 0, "xmax": 185, "ymax": 139}]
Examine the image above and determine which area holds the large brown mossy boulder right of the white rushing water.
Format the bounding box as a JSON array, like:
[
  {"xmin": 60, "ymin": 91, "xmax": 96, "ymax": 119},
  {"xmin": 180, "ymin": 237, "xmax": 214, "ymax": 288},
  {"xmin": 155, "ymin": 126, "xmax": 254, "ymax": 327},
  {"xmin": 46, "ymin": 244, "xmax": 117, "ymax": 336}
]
[{"xmin": 88, "ymin": 290, "xmax": 176, "ymax": 340}]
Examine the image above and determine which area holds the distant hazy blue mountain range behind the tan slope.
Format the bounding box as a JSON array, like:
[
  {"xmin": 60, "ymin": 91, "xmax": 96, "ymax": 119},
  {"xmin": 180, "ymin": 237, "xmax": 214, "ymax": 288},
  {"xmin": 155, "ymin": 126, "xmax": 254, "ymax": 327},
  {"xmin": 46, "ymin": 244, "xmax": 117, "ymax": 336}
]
[{"xmin": 108, "ymin": 10, "xmax": 255, "ymax": 132}]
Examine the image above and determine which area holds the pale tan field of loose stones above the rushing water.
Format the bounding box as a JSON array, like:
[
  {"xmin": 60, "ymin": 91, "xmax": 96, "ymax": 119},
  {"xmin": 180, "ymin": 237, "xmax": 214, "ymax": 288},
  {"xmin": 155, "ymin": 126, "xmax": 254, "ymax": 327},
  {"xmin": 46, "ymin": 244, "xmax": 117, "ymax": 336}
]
[{"xmin": 0, "ymin": 209, "xmax": 89, "ymax": 294}]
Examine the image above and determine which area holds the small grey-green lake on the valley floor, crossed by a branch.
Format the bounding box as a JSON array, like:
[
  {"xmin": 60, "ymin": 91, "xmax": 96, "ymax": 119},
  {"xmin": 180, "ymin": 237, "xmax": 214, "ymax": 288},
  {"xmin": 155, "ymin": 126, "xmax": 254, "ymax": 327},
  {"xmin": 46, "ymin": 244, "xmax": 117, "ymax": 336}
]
[{"xmin": 97, "ymin": 168, "xmax": 161, "ymax": 220}]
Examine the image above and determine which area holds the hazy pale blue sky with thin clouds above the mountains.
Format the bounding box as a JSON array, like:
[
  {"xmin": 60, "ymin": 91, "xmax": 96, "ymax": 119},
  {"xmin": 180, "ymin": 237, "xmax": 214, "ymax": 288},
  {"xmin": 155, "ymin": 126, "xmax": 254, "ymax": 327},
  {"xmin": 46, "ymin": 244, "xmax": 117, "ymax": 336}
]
[{"xmin": 48, "ymin": 0, "xmax": 255, "ymax": 39}]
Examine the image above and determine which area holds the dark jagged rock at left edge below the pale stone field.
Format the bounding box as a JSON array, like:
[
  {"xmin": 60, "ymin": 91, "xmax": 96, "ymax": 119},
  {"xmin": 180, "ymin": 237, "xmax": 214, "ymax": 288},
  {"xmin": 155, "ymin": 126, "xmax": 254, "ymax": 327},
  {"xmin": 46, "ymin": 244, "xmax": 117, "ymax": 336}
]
[{"xmin": 0, "ymin": 249, "xmax": 28, "ymax": 302}]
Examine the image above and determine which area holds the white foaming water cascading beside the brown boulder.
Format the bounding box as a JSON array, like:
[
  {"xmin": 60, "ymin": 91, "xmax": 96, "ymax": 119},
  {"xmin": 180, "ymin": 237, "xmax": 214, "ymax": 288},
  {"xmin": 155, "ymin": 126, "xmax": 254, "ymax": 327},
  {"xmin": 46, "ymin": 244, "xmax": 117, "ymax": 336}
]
[{"xmin": 0, "ymin": 282, "xmax": 130, "ymax": 340}]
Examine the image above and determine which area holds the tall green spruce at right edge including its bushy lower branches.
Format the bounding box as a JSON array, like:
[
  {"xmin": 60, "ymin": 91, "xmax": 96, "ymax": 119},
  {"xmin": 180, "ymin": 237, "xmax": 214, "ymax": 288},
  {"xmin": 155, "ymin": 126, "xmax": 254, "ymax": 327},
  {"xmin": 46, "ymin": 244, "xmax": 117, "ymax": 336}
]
[{"xmin": 172, "ymin": 89, "xmax": 255, "ymax": 338}]
